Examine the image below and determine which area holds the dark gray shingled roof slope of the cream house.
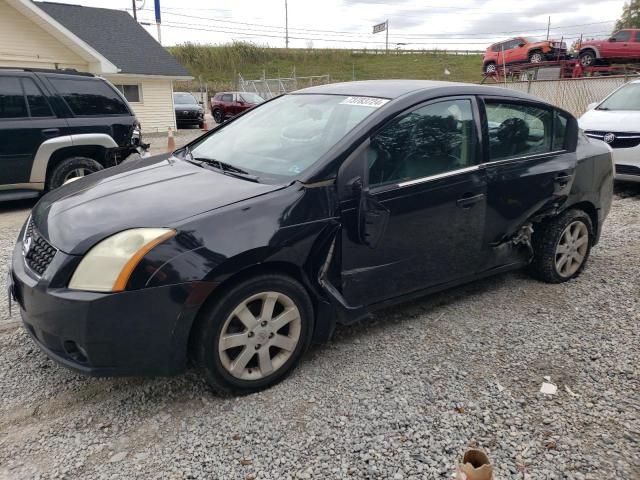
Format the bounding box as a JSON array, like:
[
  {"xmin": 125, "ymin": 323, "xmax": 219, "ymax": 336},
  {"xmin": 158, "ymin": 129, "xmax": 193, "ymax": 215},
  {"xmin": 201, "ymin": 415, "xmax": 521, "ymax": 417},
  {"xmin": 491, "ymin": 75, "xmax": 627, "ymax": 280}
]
[{"xmin": 34, "ymin": 2, "xmax": 191, "ymax": 77}]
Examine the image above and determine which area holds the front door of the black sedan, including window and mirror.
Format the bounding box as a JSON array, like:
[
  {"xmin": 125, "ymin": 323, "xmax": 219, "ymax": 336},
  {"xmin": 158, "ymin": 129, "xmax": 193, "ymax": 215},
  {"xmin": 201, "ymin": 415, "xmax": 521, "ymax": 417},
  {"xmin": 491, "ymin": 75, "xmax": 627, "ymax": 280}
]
[{"xmin": 339, "ymin": 97, "xmax": 486, "ymax": 306}]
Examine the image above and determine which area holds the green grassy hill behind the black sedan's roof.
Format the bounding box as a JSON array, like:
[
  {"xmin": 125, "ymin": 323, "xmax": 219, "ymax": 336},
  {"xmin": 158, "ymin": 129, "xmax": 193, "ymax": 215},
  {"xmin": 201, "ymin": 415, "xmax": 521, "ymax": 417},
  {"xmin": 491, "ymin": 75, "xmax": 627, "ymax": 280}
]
[{"xmin": 169, "ymin": 43, "xmax": 482, "ymax": 91}]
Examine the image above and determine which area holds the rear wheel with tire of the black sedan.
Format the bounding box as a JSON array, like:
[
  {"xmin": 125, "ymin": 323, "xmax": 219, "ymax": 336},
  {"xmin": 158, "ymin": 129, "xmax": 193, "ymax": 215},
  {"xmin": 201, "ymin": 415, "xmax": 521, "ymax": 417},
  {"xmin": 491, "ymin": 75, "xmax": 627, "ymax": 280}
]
[{"xmin": 531, "ymin": 210, "xmax": 593, "ymax": 283}]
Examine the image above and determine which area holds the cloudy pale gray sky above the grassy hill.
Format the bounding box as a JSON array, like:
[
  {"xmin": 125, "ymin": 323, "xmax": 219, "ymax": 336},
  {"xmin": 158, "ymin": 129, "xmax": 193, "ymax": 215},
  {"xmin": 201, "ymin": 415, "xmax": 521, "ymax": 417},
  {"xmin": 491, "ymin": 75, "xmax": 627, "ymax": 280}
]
[{"xmin": 41, "ymin": 0, "xmax": 624, "ymax": 50}]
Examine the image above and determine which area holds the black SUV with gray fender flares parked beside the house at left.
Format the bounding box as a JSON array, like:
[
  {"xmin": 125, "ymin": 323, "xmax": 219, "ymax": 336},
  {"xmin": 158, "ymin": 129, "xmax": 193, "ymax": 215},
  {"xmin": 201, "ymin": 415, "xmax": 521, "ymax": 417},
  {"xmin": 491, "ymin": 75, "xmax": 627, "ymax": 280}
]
[{"xmin": 0, "ymin": 69, "xmax": 147, "ymax": 200}]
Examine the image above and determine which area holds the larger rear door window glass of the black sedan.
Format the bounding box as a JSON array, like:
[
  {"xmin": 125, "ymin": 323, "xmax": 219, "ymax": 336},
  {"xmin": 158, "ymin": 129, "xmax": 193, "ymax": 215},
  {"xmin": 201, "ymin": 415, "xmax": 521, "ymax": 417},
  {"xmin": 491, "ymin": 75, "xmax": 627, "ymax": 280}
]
[{"xmin": 485, "ymin": 101, "xmax": 554, "ymax": 161}]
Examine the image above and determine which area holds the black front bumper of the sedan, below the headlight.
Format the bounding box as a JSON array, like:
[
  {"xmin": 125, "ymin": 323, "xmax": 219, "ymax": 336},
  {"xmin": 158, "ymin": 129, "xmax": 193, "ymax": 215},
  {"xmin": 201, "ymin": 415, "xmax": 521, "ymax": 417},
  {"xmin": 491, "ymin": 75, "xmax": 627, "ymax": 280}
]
[{"xmin": 9, "ymin": 242, "xmax": 213, "ymax": 376}]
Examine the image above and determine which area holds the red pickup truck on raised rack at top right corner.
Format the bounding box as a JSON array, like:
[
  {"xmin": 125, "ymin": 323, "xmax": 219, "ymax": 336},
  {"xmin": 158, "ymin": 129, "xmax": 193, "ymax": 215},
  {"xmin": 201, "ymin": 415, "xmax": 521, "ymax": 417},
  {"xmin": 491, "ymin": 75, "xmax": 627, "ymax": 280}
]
[{"xmin": 580, "ymin": 28, "xmax": 640, "ymax": 67}]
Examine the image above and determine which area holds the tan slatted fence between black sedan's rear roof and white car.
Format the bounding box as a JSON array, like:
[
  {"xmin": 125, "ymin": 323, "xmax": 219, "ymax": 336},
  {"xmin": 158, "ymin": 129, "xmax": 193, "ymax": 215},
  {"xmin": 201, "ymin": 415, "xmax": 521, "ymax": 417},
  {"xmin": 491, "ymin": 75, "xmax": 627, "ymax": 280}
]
[{"xmin": 499, "ymin": 76, "xmax": 638, "ymax": 116}]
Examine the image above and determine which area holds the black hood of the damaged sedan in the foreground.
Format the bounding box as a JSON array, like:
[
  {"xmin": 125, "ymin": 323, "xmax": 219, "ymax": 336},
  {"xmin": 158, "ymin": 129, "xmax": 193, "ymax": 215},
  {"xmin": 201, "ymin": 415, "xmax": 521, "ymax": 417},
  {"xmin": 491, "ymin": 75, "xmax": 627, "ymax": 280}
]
[{"xmin": 32, "ymin": 155, "xmax": 282, "ymax": 255}]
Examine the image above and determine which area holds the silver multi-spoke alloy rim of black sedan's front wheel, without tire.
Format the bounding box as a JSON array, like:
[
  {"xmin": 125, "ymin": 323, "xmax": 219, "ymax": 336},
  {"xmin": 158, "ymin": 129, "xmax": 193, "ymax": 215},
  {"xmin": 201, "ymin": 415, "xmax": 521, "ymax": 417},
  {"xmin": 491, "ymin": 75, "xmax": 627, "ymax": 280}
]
[{"xmin": 218, "ymin": 292, "xmax": 302, "ymax": 380}]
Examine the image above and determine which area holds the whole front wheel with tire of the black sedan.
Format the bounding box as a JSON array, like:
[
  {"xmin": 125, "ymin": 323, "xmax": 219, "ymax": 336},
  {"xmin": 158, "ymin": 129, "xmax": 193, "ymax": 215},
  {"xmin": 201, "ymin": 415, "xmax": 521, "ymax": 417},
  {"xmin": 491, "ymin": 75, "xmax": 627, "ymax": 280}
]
[{"xmin": 196, "ymin": 274, "xmax": 314, "ymax": 394}]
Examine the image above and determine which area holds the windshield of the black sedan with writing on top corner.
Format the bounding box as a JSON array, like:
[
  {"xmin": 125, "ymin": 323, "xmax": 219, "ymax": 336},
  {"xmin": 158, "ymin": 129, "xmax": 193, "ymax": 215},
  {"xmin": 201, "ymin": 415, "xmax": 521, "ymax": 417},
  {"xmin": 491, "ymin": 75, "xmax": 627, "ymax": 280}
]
[{"xmin": 185, "ymin": 94, "xmax": 388, "ymax": 183}]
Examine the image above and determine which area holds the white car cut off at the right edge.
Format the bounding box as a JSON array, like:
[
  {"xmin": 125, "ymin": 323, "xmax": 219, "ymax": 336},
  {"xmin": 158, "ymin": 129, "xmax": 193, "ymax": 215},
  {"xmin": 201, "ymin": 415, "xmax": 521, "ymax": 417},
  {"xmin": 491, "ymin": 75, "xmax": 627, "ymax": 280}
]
[{"xmin": 578, "ymin": 80, "xmax": 640, "ymax": 182}]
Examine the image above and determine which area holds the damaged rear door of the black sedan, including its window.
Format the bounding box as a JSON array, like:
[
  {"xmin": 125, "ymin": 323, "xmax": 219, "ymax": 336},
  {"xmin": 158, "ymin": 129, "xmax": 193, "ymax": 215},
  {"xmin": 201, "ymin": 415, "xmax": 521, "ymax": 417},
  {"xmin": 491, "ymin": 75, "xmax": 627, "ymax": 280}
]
[{"xmin": 483, "ymin": 98, "xmax": 577, "ymax": 270}]
